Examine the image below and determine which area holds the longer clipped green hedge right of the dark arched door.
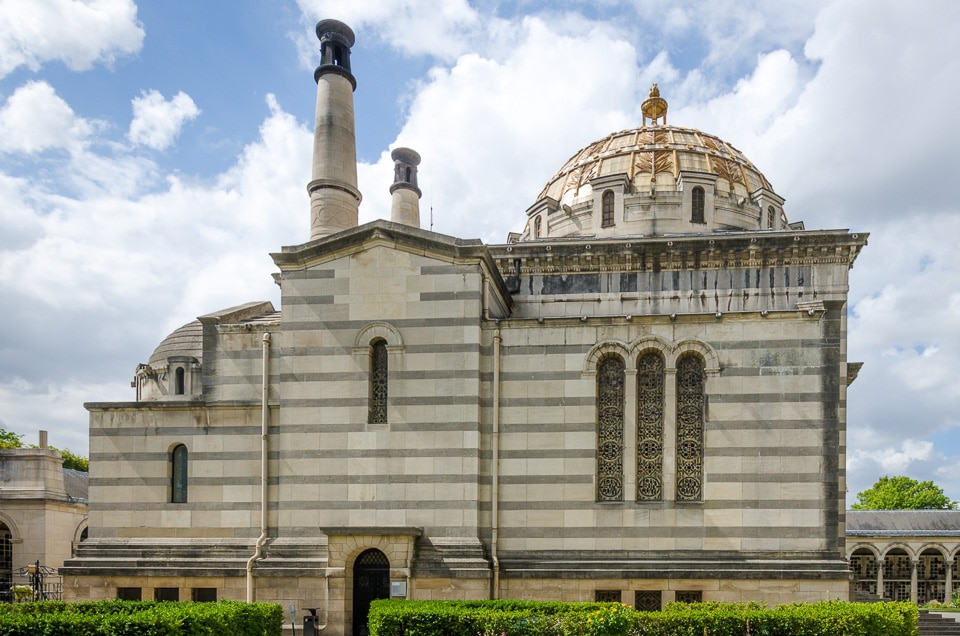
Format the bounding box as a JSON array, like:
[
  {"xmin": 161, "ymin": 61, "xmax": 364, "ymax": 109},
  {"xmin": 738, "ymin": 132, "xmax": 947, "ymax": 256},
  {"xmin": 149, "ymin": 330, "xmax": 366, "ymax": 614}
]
[{"xmin": 369, "ymin": 601, "xmax": 919, "ymax": 636}]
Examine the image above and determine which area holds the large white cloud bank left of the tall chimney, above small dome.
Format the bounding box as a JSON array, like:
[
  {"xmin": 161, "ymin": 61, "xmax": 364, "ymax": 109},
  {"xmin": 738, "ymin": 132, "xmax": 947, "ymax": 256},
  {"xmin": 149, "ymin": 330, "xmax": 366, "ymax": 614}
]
[{"xmin": 0, "ymin": 96, "xmax": 311, "ymax": 412}]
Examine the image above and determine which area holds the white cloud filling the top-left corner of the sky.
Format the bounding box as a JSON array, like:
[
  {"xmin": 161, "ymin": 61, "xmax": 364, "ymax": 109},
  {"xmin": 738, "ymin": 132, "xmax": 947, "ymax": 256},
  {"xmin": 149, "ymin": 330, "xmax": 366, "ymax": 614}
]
[{"xmin": 0, "ymin": 0, "xmax": 144, "ymax": 77}]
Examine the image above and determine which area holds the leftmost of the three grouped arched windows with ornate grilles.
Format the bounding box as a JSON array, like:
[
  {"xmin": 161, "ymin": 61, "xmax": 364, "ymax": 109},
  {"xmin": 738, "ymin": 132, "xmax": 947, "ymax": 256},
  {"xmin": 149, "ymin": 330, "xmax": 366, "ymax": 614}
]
[{"xmin": 597, "ymin": 355, "xmax": 624, "ymax": 501}]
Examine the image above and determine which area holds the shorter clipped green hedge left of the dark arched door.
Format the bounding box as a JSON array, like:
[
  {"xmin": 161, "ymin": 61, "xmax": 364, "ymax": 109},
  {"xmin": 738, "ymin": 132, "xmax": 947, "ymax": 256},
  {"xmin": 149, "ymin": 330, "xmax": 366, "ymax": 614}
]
[{"xmin": 0, "ymin": 601, "xmax": 283, "ymax": 636}]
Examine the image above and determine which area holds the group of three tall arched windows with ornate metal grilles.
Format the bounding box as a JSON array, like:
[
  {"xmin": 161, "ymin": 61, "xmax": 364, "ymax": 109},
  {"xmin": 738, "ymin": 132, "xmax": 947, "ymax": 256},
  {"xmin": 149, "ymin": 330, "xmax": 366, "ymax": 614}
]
[{"xmin": 596, "ymin": 350, "xmax": 706, "ymax": 502}]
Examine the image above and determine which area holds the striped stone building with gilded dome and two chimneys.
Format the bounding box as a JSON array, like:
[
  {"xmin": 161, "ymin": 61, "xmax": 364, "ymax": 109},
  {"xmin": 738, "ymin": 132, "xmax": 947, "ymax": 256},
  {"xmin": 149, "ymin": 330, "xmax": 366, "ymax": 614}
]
[{"xmin": 63, "ymin": 20, "xmax": 867, "ymax": 634}]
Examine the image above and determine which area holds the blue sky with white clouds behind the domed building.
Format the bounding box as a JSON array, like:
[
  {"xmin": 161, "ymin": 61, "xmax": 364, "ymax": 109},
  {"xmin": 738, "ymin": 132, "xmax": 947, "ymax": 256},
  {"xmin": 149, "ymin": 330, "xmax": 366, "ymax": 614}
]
[{"xmin": 0, "ymin": 0, "xmax": 960, "ymax": 501}]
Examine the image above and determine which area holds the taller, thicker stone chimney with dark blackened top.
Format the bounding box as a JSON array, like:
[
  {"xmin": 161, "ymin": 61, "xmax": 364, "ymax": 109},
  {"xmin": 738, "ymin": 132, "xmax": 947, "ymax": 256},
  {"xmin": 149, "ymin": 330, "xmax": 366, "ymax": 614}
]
[{"xmin": 307, "ymin": 20, "xmax": 361, "ymax": 241}]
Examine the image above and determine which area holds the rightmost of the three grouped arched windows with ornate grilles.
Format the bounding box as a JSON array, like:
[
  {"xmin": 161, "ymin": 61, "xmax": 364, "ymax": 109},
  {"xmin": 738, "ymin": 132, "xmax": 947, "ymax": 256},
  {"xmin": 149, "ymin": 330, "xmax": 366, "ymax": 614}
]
[{"xmin": 677, "ymin": 355, "xmax": 706, "ymax": 501}]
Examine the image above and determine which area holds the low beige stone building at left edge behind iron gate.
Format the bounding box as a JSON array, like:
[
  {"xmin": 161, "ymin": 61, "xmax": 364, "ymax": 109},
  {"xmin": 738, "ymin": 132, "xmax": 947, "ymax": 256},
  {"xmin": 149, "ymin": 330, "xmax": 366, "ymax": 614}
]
[{"xmin": 0, "ymin": 431, "xmax": 87, "ymax": 601}]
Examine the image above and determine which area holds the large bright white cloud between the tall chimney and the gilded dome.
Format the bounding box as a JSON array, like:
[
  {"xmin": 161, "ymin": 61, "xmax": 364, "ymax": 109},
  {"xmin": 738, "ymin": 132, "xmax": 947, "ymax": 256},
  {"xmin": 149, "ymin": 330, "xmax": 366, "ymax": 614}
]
[{"xmin": 360, "ymin": 18, "xmax": 647, "ymax": 242}]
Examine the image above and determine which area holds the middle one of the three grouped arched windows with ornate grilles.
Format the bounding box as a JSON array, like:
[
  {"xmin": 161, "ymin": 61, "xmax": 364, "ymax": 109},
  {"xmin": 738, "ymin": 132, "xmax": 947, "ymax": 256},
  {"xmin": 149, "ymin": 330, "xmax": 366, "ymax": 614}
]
[{"xmin": 637, "ymin": 351, "xmax": 664, "ymax": 501}]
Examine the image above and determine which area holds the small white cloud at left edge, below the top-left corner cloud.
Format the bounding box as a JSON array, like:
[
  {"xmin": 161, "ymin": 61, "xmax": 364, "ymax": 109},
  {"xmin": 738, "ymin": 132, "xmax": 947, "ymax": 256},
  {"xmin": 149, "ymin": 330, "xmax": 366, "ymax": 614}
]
[{"xmin": 0, "ymin": 81, "xmax": 92, "ymax": 154}]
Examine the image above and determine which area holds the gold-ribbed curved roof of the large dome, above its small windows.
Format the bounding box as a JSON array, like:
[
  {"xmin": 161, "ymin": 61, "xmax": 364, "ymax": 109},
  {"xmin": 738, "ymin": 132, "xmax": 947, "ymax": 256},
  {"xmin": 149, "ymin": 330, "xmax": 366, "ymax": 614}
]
[{"xmin": 537, "ymin": 125, "xmax": 773, "ymax": 204}]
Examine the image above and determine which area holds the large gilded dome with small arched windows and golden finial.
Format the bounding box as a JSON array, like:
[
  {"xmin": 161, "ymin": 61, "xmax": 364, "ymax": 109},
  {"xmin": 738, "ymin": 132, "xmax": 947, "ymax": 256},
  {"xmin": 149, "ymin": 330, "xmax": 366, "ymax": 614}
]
[{"xmin": 520, "ymin": 84, "xmax": 787, "ymax": 240}]
